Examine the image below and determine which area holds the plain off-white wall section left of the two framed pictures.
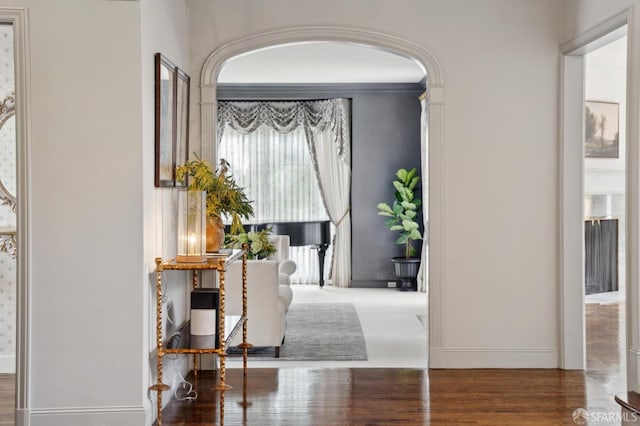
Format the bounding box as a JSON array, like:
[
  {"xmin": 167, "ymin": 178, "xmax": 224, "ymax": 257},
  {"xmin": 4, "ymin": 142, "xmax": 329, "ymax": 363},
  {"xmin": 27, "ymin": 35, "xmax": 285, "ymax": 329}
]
[{"xmin": 4, "ymin": 0, "xmax": 168, "ymax": 426}]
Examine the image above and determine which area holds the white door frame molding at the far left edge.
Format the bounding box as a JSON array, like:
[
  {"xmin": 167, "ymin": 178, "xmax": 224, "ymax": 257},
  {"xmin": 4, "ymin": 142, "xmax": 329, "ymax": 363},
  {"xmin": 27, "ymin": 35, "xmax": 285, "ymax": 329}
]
[{"xmin": 0, "ymin": 7, "xmax": 31, "ymax": 426}]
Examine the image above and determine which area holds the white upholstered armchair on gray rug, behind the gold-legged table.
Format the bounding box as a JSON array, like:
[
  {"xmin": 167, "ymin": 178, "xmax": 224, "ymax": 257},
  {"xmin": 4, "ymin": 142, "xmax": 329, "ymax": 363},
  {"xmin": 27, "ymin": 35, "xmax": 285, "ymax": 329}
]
[{"xmin": 225, "ymin": 235, "xmax": 296, "ymax": 357}]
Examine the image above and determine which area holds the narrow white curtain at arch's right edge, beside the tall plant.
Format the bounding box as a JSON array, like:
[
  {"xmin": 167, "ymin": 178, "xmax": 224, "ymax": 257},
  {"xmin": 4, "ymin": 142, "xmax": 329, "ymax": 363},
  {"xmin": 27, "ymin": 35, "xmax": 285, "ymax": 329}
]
[{"xmin": 418, "ymin": 95, "xmax": 429, "ymax": 292}]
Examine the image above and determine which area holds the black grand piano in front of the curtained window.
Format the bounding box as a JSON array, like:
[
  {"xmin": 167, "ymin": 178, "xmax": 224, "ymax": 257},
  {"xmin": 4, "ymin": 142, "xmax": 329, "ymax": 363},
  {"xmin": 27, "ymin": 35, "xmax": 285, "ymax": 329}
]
[{"xmin": 248, "ymin": 220, "xmax": 331, "ymax": 287}]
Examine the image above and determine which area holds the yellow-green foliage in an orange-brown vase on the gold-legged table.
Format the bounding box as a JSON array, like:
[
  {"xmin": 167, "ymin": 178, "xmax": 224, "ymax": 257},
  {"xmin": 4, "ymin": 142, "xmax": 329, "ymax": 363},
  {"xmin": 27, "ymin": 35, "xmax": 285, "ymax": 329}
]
[{"xmin": 176, "ymin": 157, "xmax": 253, "ymax": 252}]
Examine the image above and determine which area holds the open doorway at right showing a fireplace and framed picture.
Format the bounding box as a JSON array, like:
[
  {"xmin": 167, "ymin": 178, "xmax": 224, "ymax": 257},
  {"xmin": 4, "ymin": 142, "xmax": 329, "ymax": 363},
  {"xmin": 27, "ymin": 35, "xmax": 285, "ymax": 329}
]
[{"xmin": 583, "ymin": 35, "xmax": 627, "ymax": 389}]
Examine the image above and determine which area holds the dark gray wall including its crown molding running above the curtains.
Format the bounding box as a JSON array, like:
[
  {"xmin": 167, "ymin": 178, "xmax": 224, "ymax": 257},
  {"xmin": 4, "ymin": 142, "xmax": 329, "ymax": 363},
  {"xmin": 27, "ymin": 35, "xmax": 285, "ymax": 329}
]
[{"xmin": 218, "ymin": 83, "xmax": 424, "ymax": 287}]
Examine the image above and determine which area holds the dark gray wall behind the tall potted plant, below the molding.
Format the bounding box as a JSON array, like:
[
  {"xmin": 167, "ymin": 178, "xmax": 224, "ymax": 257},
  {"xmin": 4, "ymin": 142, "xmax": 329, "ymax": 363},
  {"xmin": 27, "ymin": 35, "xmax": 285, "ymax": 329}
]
[{"xmin": 351, "ymin": 94, "xmax": 422, "ymax": 286}]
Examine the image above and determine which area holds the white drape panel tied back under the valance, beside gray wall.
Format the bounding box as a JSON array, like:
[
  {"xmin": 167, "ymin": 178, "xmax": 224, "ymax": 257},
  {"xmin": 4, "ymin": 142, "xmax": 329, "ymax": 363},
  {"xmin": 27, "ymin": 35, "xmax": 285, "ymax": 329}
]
[{"xmin": 313, "ymin": 129, "xmax": 351, "ymax": 287}]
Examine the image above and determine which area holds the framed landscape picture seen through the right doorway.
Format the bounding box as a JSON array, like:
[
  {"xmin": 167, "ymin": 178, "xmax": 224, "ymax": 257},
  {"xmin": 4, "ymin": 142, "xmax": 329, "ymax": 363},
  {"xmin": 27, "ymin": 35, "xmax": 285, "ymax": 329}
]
[{"xmin": 584, "ymin": 101, "xmax": 620, "ymax": 158}]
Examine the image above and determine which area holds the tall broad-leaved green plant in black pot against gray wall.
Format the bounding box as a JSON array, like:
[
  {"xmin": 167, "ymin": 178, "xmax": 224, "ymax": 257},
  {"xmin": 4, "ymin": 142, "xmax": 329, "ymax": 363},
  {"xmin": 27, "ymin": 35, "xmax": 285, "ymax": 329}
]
[{"xmin": 378, "ymin": 168, "xmax": 422, "ymax": 290}]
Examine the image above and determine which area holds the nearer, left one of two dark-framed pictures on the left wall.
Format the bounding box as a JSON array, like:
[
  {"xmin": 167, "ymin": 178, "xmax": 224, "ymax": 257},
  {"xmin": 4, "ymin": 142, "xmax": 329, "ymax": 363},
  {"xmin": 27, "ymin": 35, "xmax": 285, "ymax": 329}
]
[{"xmin": 155, "ymin": 53, "xmax": 176, "ymax": 187}]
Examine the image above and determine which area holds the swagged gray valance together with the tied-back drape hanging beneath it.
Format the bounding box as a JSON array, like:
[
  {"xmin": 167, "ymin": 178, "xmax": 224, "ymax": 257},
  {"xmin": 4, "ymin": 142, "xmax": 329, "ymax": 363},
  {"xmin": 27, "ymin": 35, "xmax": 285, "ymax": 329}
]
[{"xmin": 218, "ymin": 99, "xmax": 351, "ymax": 287}]
